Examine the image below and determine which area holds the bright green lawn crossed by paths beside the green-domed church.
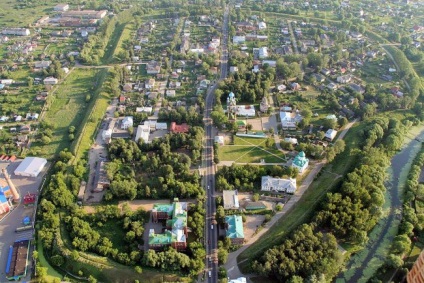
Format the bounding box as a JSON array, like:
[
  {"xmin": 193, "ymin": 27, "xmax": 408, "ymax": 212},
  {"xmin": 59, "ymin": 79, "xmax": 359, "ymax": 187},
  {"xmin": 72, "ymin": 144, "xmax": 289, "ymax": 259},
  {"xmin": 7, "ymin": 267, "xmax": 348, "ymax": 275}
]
[{"xmin": 219, "ymin": 136, "xmax": 286, "ymax": 163}]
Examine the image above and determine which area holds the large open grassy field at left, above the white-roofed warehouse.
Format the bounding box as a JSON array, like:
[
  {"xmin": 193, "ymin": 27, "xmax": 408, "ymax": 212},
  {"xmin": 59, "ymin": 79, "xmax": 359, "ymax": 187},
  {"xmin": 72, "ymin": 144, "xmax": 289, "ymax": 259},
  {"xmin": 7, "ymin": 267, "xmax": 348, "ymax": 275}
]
[{"xmin": 34, "ymin": 69, "xmax": 102, "ymax": 158}]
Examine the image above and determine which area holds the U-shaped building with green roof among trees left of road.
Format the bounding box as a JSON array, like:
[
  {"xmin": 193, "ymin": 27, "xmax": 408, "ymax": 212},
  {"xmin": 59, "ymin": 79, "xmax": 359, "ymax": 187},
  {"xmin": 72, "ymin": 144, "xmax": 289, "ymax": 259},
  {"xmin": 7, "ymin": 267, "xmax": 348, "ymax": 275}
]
[{"xmin": 149, "ymin": 199, "xmax": 188, "ymax": 251}]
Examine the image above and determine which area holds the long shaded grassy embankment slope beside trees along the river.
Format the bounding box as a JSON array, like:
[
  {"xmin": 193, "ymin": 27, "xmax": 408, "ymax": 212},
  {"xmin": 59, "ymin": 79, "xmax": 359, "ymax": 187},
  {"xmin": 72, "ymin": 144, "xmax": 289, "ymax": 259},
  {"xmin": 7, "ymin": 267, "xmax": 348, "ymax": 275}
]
[{"xmin": 237, "ymin": 121, "xmax": 362, "ymax": 273}]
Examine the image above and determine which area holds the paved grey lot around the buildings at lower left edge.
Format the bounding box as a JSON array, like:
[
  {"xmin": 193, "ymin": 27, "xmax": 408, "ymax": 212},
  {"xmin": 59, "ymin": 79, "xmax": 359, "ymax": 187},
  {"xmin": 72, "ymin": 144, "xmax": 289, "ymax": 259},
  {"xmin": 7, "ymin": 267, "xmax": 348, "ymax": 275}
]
[{"xmin": 0, "ymin": 160, "xmax": 50, "ymax": 282}]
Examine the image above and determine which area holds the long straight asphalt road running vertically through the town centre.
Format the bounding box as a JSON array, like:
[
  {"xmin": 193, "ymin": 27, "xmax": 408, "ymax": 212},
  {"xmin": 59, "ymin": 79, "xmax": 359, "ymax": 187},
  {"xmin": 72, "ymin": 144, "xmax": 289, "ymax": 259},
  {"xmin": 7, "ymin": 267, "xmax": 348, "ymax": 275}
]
[{"xmin": 203, "ymin": 7, "xmax": 229, "ymax": 283}]
